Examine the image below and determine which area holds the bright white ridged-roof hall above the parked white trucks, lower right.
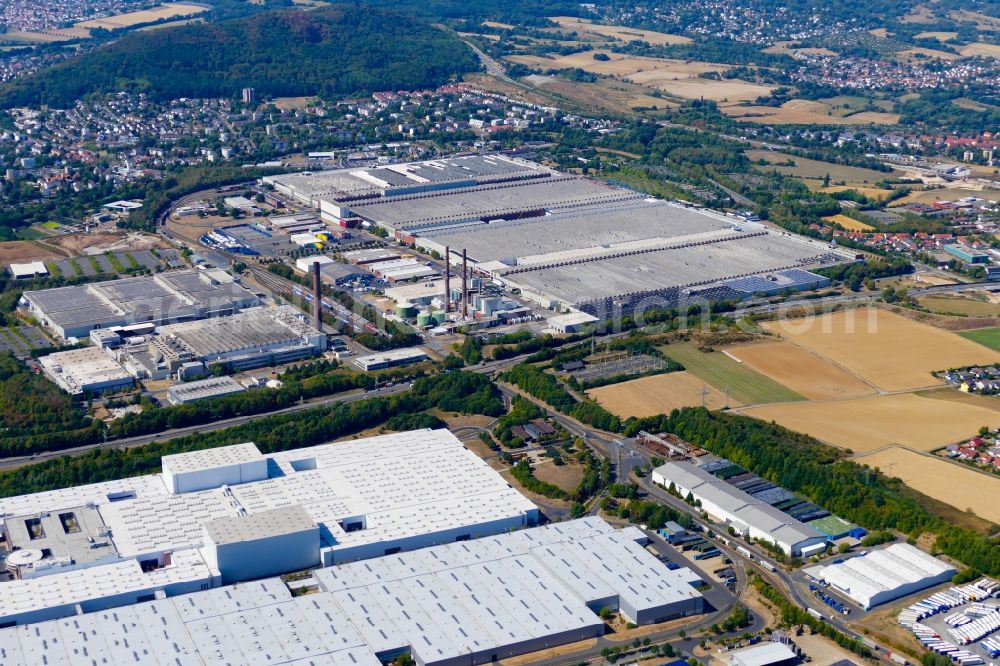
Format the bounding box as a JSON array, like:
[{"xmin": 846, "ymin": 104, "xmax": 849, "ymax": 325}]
[{"xmin": 810, "ymin": 543, "xmax": 955, "ymax": 608}]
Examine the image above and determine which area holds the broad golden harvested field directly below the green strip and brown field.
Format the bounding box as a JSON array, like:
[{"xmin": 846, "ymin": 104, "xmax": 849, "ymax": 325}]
[{"xmin": 740, "ymin": 393, "xmax": 1000, "ymax": 453}]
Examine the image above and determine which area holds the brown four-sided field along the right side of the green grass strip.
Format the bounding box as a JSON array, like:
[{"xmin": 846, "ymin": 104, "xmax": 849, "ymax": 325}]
[{"xmin": 726, "ymin": 342, "xmax": 875, "ymax": 400}]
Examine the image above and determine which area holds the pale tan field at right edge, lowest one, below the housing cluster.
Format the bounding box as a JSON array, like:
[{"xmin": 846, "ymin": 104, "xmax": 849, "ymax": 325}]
[{"xmin": 857, "ymin": 446, "xmax": 1000, "ymax": 523}]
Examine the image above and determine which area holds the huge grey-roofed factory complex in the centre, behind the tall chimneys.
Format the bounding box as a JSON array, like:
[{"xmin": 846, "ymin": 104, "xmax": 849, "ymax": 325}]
[{"xmin": 264, "ymin": 155, "xmax": 855, "ymax": 318}]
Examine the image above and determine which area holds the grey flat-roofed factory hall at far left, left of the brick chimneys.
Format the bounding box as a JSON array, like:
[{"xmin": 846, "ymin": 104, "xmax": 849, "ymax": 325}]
[{"xmin": 21, "ymin": 269, "xmax": 259, "ymax": 340}]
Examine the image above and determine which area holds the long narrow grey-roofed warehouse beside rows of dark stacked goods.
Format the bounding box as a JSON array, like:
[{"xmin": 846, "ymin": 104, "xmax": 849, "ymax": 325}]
[{"xmin": 652, "ymin": 462, "xmax": 827, "ymax": 557}]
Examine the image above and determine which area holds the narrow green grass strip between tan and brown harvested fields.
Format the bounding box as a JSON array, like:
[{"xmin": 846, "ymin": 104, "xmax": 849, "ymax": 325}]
[{"xmin": 660, "ymin": 338, "xmax": 804, "ymax": 405}]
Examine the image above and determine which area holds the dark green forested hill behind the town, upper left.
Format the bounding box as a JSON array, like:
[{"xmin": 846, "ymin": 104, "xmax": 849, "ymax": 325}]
[{"xmin": 0, "ymin": 5, "xmax": 479, "ymax": 108}]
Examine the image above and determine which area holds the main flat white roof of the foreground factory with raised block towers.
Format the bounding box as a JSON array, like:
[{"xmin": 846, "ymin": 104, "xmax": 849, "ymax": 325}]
[{"xmin": 0, "ymin": 430, "xmax": 537, "ymax": 564}]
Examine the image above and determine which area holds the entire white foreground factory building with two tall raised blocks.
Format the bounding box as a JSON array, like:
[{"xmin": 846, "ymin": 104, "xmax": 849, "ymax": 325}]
[{"xmin": 0, "ymin": 430, "xmax": 538, "ymax": 625}]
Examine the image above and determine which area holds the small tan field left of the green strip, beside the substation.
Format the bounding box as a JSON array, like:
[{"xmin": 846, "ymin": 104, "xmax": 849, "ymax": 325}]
[{"xmin": 587, "ymin": 372, "xmax": 735, "ymax": 419}]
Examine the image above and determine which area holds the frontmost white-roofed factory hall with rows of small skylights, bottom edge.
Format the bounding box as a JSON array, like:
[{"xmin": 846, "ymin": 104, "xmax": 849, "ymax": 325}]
[{"xmin": 0, "ymin": 518, "xmax": 703, "ymax": 666}]
